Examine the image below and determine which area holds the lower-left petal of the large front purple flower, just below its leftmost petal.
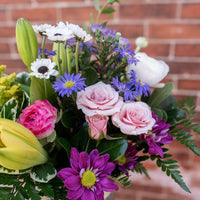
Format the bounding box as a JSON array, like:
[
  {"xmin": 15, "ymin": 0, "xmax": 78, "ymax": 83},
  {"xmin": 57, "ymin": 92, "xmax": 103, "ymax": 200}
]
[{"xmin": 64, "ymin": 175, "xmax": 81, "ymax": 190}]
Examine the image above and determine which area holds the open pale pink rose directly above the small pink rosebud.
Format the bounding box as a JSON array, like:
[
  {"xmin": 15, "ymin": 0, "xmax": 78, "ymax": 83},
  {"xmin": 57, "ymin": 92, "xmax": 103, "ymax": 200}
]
[{"xmin": 76, "ymin": 82, "xmax": 123, "ymax": 116}]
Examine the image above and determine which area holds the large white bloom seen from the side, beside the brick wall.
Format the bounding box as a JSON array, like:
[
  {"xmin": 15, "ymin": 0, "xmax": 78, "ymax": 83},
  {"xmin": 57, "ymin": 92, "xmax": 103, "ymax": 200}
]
[{"xmin": 127, "ymin": 53, "xmax": 169, "ymax": 87}]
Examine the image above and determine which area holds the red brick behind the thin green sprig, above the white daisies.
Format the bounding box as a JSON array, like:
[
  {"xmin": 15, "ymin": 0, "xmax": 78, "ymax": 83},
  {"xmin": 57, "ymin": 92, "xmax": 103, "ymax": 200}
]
[{"xmin": 61, "ymin": 7, "xmax": 112, "ymax": 23}]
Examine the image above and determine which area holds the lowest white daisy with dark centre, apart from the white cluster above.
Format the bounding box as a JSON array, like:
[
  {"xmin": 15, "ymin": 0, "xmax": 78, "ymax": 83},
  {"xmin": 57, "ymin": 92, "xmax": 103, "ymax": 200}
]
[{"xmin": 29, "ymin": 59, "xmax": 58, "ymax": 79}]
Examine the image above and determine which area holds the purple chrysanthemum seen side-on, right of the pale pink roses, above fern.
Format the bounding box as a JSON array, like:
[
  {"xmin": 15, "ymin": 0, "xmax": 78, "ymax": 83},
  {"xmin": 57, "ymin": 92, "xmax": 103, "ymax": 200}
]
[{"xmin": 140, "ymin": 111, "xmax": 173, "ymax": 158}]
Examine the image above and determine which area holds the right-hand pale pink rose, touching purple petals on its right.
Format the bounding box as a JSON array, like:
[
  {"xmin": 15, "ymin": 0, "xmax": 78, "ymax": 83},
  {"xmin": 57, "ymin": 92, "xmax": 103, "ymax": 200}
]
[{"xmin": 112, "ymin": 102, "xmax": 155, "ymax": 135}]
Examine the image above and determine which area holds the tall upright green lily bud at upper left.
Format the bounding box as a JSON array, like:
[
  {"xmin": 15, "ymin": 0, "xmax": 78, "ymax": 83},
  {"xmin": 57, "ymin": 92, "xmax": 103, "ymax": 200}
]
[{"xmin": 16, "ymin": 18, "xmax": 38, "ymax": 72}]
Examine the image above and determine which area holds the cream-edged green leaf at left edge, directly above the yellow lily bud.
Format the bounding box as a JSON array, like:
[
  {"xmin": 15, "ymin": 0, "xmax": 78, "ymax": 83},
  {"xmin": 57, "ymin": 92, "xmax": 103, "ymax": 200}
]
[{"xmin": 1, "ymin": 97, "xmax": 18, "ymax": 121}]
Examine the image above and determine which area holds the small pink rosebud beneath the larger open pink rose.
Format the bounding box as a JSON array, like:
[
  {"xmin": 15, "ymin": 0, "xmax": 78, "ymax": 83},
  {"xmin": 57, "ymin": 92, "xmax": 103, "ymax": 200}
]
[{"xmin": 86, "ymin": 115, "xmax": 109, "ymax": 140}]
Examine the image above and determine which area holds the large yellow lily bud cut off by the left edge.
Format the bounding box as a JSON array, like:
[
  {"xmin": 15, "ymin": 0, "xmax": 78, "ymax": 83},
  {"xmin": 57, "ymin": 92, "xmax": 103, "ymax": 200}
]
[{"xmin": 0, "ymin": 118, "xmax": 47, "ymax": 170}]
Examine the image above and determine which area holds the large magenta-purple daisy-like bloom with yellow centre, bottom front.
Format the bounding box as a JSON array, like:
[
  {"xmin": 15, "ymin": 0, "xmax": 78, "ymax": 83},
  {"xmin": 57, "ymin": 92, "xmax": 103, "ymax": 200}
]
[{"xmin": 57, "ymin": 148, "xmax": 118, "ymax": 200}]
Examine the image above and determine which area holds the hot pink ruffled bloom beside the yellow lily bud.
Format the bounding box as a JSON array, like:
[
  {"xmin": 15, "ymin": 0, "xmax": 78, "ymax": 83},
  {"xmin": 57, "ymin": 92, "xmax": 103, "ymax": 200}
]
[{"xmin": 18, "ymin": 100, "xmax": 57, "ymax": 139}]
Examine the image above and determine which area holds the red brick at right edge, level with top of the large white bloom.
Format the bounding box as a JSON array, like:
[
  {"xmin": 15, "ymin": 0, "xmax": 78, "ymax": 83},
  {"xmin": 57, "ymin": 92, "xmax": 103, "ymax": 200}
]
[{"xmin": 175, "ymin": 44, "xmax": 200, "ymax": 57}]
